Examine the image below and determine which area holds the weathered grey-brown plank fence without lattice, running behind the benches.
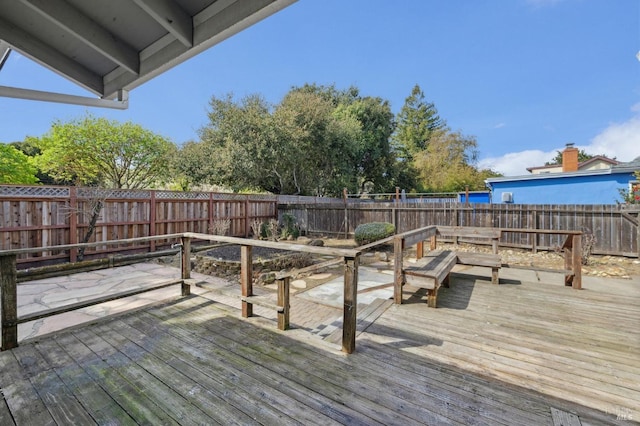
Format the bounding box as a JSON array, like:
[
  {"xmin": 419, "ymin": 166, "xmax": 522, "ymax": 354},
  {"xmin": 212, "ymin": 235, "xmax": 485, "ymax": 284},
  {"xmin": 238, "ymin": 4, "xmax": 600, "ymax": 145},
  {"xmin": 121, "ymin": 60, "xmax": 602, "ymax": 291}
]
[{"xmin": 279, "ymin": 201, "xmax": 640, "ymax": 257}]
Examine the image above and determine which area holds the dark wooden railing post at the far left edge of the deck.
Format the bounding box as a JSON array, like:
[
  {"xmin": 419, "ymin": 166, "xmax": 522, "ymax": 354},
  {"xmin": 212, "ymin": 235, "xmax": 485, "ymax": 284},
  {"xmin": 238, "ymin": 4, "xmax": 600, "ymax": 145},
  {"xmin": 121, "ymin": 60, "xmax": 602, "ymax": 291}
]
[{"xmin": 0, "ymin": 255, "xmax": 18, "ymax": 351}]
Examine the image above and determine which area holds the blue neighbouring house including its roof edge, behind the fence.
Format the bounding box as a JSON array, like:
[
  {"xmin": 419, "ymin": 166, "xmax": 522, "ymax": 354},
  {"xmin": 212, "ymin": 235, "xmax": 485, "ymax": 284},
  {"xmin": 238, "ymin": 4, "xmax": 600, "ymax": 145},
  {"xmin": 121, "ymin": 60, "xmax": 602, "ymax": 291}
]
[{"xmin": 485, "ymin": 157, "xmax": 640, "ymax": 204}]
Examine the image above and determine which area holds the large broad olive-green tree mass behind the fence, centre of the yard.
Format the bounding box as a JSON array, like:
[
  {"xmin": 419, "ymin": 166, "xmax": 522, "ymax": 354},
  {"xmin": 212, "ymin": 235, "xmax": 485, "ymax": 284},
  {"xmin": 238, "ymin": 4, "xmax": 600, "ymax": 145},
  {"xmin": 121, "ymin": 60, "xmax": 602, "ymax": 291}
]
[{"xmin": 188, "ymin": 85, "xmax": 402, "ymax": 195}]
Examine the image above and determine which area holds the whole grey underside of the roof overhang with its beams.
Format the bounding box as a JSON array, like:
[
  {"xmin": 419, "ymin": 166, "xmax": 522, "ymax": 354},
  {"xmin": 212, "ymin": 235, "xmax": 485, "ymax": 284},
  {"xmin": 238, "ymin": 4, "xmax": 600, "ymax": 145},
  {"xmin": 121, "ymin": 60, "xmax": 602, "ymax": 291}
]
[{"xmin": 0, "ymin": 0, "xmax": 296, "ymax": 106}]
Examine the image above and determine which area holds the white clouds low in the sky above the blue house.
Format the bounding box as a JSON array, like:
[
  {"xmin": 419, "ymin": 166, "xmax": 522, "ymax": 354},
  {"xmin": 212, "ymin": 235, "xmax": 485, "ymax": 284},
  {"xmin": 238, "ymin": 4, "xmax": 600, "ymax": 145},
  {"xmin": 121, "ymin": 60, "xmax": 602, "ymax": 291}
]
[{"xmin": 478, "ymin": 111, "xmax": 640, "ymax": 176}]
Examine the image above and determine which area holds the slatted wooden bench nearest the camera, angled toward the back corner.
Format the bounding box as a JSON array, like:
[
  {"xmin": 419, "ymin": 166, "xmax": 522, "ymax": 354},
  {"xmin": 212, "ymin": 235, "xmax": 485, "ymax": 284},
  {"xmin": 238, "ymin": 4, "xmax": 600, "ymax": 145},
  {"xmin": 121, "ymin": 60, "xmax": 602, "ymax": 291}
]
[{"xmin": 402, "ymin": 250, "xmax": 458, "ymax": 308}]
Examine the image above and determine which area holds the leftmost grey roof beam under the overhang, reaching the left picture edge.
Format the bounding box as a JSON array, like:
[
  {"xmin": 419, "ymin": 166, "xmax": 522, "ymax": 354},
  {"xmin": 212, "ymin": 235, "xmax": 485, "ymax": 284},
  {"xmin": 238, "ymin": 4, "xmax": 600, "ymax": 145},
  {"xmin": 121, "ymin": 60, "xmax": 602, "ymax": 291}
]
[{"xmin": 0, "ymin": 17, "xmax": 104, "ymax": 96}]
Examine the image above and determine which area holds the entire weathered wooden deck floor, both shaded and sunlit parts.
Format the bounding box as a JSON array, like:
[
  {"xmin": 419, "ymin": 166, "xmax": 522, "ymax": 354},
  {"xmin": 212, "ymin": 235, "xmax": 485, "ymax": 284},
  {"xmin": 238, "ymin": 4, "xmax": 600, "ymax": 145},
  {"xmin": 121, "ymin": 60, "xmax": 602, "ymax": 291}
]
[{"xmin": 0, "ymin": 273, "xmax": 640, "ymax": 426}]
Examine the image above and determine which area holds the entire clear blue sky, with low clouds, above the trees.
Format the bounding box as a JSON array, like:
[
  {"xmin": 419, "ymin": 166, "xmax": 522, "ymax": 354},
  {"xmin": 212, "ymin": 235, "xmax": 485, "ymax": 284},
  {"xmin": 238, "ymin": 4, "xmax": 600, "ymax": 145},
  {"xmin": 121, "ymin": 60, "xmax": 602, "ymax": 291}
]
[{"xmin": 0, "ymin": 0, "xmax": 640, "ymax": 175}]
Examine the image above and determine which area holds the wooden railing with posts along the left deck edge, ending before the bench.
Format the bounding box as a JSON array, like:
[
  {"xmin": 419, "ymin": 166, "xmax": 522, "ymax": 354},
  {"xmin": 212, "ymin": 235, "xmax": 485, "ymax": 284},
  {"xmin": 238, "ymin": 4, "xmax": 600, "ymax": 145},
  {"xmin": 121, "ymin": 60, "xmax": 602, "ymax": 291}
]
[{"xmin": 0, "ymin": 232, "xmax": 361, "ymax": 353}]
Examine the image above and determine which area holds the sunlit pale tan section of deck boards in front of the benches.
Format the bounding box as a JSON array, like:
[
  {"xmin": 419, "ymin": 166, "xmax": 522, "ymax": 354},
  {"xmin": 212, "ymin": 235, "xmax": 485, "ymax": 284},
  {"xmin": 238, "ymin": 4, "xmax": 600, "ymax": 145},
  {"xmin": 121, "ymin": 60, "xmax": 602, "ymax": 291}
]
[{"xmin": 382, "ymin": 273, "xmax": 640, "ymax": 422}]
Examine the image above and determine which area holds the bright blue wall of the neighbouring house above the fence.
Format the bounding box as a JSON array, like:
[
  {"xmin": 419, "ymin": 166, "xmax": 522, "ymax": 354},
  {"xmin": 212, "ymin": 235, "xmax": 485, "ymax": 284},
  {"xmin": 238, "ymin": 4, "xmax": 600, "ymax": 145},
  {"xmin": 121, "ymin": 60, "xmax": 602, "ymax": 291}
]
[{"xmin": 490, "ymin": 173, "xmax": 635, "ymax": 204}]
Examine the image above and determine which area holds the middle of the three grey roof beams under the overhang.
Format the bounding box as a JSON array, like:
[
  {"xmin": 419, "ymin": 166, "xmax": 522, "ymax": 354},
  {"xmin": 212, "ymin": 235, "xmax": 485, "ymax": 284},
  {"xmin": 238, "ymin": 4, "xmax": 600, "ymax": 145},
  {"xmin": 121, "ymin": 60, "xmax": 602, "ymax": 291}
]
[{"xmin": 21, "ymin": 0, "xmax": 140, "ymax": 75}]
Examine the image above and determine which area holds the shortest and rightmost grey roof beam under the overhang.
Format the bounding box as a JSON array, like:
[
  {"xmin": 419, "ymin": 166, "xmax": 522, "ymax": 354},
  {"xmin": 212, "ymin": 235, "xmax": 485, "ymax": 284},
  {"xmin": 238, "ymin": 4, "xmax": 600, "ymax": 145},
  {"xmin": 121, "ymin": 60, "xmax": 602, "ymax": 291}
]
[{"xmin": 133, "ymin": 0, "xmax": 193, "ymax": 47}]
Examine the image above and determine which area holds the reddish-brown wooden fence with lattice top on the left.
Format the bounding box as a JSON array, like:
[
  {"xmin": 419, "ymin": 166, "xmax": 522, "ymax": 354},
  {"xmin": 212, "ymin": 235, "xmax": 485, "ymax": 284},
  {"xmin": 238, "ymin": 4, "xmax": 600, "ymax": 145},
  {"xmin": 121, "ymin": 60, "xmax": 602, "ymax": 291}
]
[{"xmin": 0, "ymin": 185, "xmax": 278, "ymax": 268}]
